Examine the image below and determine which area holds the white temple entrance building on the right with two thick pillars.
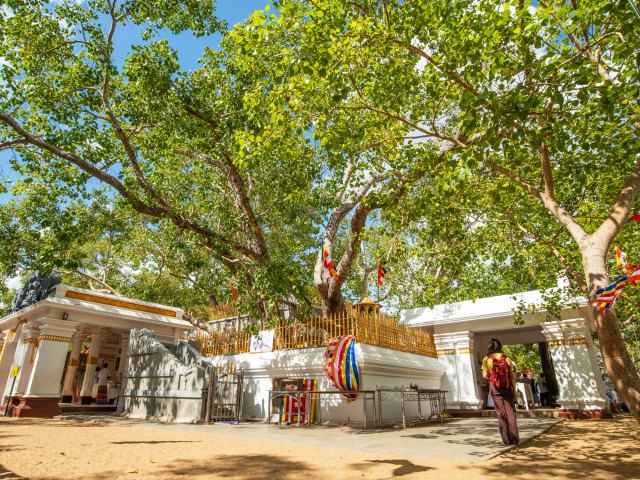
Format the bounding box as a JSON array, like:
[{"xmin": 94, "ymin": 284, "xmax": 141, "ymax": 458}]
[{"xmin": 400, "ymin": 290, "xmax": 608, "ymax": 418}]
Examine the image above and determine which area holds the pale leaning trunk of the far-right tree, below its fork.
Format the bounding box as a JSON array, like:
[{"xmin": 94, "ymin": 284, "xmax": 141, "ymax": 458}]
[{"xmin": 581, "ymin": 246, "xmax": 640, "ymax": 422}]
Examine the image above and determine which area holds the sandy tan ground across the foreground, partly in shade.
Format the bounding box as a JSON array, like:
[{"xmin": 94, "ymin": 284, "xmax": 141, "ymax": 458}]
[{"xmin": 0, "ymin": 416, "xmax": 640, "ymax": 480}]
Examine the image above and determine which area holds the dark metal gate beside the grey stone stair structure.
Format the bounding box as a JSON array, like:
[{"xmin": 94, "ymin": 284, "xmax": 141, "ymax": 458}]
[{"xmin": 204, "ymin": 366, "xmax": 244, "ymax": 423}]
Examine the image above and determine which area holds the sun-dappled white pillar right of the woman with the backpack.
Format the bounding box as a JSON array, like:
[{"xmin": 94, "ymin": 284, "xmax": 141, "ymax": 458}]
[{"xmin": 542, "ymin": 318, "xmax": 608, "ymax": 411}]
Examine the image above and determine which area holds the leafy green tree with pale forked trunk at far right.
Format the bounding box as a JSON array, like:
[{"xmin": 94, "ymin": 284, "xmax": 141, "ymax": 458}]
[{"xmin": 255, "ymin": 0, "xmax": 640, "ymax": 421}]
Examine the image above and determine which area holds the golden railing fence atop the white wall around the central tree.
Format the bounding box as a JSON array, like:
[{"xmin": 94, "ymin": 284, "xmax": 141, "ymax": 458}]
[{"xmin": 195, "ymin": 311, "xmax": 437, "ymax": 358}]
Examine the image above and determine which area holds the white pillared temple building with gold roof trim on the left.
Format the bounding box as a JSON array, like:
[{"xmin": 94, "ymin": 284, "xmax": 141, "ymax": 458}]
[{"xmin": 0, "ymin": 285, "xmax": 193, "ymax": 416}]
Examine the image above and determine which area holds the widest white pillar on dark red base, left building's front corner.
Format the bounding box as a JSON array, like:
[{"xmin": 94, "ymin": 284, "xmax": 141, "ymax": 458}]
[{"xmin": 13, "ymin": 318, "xmax": 78, "ymax": 417}]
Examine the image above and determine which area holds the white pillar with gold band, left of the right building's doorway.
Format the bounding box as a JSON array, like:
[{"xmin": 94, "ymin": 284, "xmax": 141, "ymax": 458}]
[{"xmin": 433, "ymin": 331, "xmax": 482, "ymax": 410}]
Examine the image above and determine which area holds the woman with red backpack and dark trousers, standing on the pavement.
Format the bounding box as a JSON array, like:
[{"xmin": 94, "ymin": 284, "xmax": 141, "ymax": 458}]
[{"xmin": 482, "ymin": 338, "xmax": 520, "ymax": 445}]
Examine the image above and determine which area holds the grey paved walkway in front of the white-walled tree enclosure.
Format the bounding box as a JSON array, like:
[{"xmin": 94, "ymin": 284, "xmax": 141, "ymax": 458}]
[{"xmin": 60, "ymin": 414, "xmax": 561, "ymax": 462}]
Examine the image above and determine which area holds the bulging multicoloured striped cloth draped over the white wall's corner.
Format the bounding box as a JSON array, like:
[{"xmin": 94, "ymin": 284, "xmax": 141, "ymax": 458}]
[{"xmin": 324, "ymin": 335, "xmax": 360, "ymax": 401}]
